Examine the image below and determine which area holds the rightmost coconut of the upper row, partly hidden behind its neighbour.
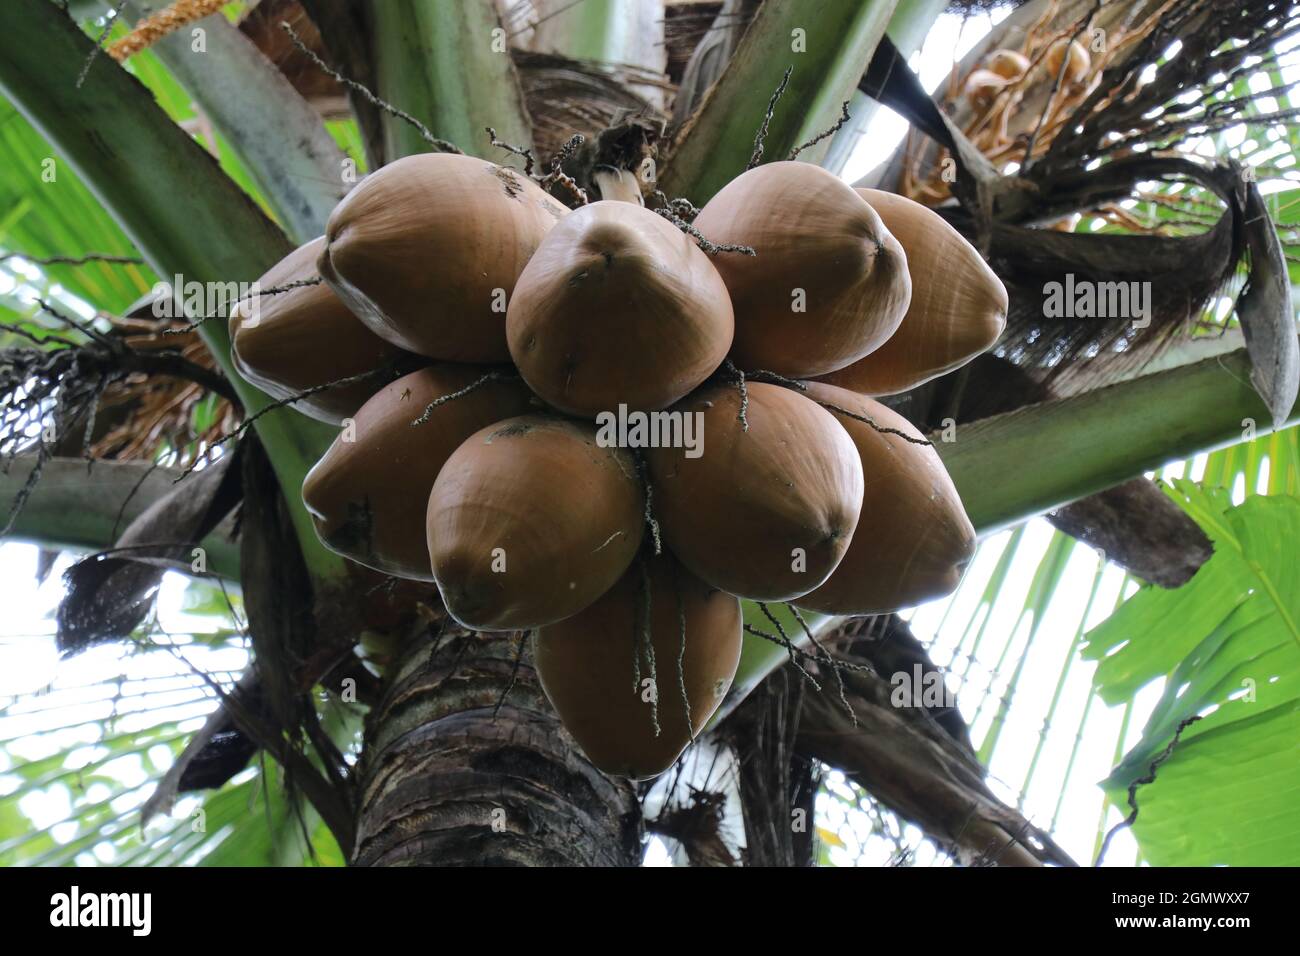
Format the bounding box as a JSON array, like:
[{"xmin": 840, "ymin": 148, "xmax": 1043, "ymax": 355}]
[{"xmin": 822, "ymin": 189, "xmax": 1006, "ymax": 395}]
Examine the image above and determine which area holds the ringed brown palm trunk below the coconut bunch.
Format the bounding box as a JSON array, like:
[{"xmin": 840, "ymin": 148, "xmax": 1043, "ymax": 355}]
[{"xmin": 352, "ymin": 631, "xmax": 641, "ymax": 866}]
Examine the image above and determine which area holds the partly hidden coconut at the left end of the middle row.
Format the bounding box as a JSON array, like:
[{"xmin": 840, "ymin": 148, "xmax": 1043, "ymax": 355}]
[{"xmin": 303, "ymin": 364, "xmax": 536, "ymax": 581}]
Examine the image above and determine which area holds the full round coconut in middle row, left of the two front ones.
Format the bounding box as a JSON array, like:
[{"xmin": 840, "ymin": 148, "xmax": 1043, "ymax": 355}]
[{"xmin": 425, "ymin": 415, "xmax": 645, "ymax": 631}]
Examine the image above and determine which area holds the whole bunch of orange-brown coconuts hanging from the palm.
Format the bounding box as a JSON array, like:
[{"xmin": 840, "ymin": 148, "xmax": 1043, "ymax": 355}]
[{"xmin": 230, "ymin": 153, "xmax": 1006, "ymax": 777}]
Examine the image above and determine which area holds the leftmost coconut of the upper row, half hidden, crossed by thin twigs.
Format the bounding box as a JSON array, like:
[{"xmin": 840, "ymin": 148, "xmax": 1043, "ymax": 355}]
[{"xmin": 230, "ymin": 237, "xmax": 403, "ymax": 425}]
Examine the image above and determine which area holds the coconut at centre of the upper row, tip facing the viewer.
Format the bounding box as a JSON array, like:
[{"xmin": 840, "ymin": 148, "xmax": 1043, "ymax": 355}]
[{"xmin": 506, "ymin": 202, "xmax": 733, "ymax": 416}]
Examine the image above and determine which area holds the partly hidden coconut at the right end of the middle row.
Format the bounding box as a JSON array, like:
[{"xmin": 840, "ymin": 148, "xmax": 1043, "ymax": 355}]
[{"xmin": 798, "ymin": 382, "xmax": 975, "ymax": 614}]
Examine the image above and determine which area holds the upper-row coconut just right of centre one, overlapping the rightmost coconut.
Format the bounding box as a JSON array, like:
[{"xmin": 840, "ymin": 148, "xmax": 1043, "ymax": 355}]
[{"xmin": 694, "ymin": 163, "xmax": 911, "ymax": 377}]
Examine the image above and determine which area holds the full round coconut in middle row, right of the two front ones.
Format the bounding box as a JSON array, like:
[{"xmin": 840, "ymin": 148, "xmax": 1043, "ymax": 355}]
[{"xmin": 647, "ymin": 382, "xmax": 863, "ymax": 601}]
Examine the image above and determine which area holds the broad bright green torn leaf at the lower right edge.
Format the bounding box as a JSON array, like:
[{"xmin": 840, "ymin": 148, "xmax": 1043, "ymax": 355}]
[{"xmin": 1084, "ymin": 480, "xmax": 1300, "ymax": 865}]
